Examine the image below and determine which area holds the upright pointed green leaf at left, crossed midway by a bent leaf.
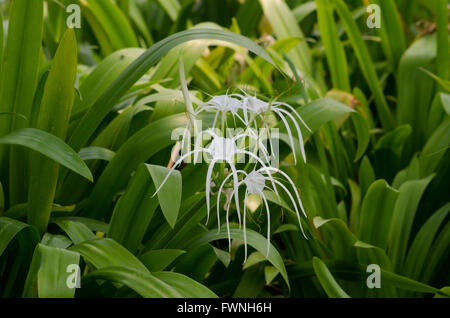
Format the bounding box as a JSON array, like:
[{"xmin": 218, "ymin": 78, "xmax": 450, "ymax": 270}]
[{"xmin": 28, "ymin": 29, "xmax": 78, "ymax": 233}]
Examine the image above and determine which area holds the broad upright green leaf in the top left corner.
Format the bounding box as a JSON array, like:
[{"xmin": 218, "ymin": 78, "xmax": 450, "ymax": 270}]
[{"xmin": 0, "ymin": 0, "xmax": 44, "ymax": 191}]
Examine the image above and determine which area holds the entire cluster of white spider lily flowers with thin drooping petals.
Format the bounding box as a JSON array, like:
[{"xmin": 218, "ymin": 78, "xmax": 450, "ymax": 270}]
[{"xmin": 155, "ymin": 64, "xmax": 309, "ymax": 259}]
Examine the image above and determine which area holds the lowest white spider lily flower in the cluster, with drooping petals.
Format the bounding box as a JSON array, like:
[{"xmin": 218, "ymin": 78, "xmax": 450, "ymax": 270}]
[{"xmin": 217, "ymin": 167, "xmax": 307, "ymax": 262}]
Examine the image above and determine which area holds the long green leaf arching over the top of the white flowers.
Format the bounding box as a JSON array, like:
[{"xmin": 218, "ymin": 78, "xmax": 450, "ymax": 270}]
[{"xmin": 70, "ymin": 29, "xmax": 275, "ymax": 150}]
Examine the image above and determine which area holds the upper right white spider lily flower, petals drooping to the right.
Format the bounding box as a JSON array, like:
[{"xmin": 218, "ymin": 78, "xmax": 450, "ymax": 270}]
[{"xmin": 233, "ymin": 92, "xmax": 311, "ymax": 163}]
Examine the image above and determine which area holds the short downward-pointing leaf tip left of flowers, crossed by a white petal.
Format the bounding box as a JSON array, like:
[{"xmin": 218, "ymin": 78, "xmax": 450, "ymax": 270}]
[{"xmin": 147, "ymin": 165, "xmax": 182, "ymax": 228}]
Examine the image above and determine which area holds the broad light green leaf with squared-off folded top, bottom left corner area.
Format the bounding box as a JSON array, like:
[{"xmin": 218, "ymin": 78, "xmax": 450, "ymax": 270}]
[{"xmin": 22, "ymin": 244, "xmax": 80, "ymax": 298}]
